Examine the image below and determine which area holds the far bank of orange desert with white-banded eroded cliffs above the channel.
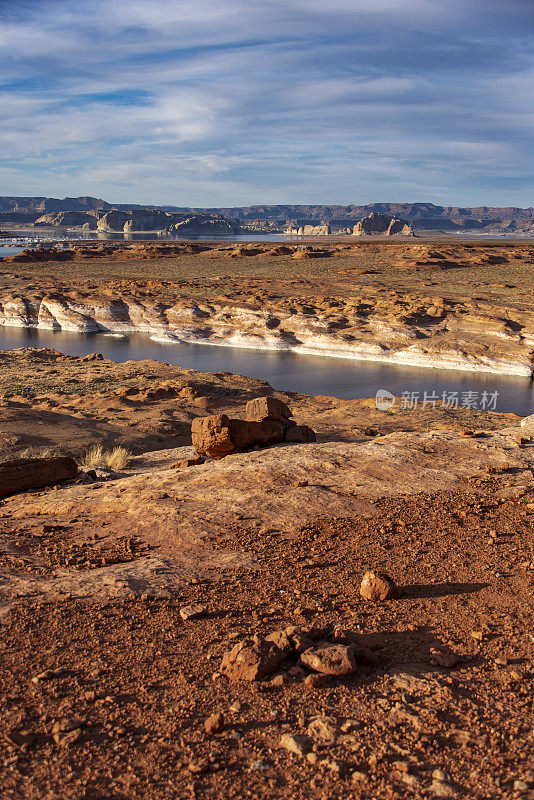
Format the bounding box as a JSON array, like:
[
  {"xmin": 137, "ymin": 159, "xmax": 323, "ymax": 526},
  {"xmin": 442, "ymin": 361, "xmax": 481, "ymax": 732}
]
[{"xmin": 0, "ymin": 238, "xmax": 534, "ymax": 378}]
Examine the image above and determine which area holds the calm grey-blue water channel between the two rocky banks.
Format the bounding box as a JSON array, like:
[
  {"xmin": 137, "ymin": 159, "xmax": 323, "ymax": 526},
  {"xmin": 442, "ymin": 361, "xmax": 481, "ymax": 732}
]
[{"xmin": 0, "ymin": 327, "xmax": 534, "ymax": 415}]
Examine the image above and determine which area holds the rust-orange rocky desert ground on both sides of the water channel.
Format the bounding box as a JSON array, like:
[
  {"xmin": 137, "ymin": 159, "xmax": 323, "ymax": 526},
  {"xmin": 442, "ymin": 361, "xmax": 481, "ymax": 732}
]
[{"xmin": 0, "ymin": 238, "xmax": 534, "ymax": 800}]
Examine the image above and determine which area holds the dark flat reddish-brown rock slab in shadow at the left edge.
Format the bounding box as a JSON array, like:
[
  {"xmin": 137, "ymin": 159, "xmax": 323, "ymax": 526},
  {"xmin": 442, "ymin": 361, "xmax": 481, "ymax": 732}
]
[{"xmin": 0, "ymin": 456, "xmax": 78, "ymax": 497}]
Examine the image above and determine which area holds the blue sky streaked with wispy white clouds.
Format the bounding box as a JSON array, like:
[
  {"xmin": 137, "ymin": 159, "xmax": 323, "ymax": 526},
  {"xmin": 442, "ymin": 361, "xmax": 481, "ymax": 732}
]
[{"xmin": 0, "ymin": 0, "xmax": 534, "ymax": 207}]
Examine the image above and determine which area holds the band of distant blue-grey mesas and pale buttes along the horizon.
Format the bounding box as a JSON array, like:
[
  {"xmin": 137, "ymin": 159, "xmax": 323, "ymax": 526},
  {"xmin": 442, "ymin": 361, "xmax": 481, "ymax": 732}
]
[{"xmin": 0, "ymin": 196, "xmax": 534, "ymax": 236}]
